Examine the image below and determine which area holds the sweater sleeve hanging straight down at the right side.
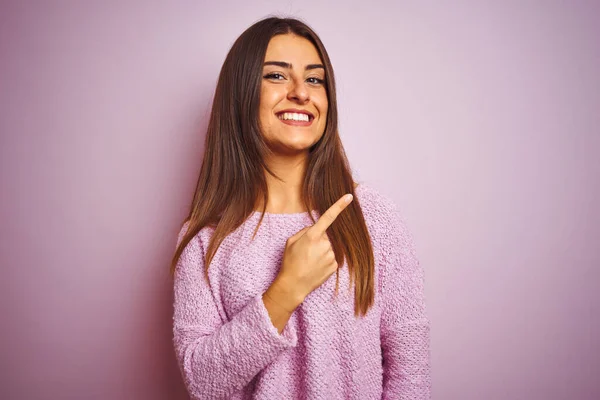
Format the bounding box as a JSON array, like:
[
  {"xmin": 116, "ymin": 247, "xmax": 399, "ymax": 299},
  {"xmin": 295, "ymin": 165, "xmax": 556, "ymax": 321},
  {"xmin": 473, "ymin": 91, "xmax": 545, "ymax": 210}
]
[{"xmin": 381, "ymin": 204, "xmax": 431, "ymax": 400}]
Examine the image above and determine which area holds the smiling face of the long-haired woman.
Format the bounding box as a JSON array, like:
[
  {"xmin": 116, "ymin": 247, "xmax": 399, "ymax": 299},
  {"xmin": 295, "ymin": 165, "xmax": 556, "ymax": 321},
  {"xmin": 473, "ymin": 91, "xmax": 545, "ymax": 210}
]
[{"xmin": 259, "ymin": 34, "xmax": 328, "ymax": 154}]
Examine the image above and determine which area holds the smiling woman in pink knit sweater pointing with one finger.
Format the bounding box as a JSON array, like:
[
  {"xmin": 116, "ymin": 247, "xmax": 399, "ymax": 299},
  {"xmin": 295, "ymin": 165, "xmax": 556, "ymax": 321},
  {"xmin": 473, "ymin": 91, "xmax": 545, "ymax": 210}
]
[{"xmin": 171, "ymin": 18, "xmax": 430, "ymax": 400}]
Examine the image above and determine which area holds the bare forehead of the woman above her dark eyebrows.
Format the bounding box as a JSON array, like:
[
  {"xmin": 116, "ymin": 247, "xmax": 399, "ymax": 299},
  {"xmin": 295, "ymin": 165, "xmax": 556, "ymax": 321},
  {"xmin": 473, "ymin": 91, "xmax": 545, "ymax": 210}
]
[{"xmin": 265, "ymin": 34, "xmax": 322, "ymax": 67}]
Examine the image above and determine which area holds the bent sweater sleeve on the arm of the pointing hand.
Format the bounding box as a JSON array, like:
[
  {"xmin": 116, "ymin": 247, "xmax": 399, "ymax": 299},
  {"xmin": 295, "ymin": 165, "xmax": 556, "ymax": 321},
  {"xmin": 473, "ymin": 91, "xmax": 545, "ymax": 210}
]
[{"xmin": 173, "ymin": 224, "xmax": 297, "ymax": 399}]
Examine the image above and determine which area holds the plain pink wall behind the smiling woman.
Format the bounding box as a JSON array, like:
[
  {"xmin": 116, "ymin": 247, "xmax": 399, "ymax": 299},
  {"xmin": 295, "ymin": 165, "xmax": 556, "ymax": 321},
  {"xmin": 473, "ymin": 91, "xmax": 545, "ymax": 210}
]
[{"xmin": 0, "ymin": 0, "xmax": 600, "ymax": 400}]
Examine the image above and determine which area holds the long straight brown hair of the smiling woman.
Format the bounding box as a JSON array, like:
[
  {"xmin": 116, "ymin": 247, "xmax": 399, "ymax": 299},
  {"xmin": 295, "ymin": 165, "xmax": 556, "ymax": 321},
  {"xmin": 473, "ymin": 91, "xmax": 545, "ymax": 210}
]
[{"xmin": 171, "ymin": 17, "xmax": 375, "ymax": 316}]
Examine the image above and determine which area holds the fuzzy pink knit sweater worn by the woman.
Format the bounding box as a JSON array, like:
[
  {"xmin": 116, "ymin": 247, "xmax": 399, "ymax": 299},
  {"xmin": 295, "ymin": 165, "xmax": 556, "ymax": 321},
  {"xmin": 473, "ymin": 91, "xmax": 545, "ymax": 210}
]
[{"xmin": 173, "ymin": 183, "xmax": 431, "ymax": 400}]
